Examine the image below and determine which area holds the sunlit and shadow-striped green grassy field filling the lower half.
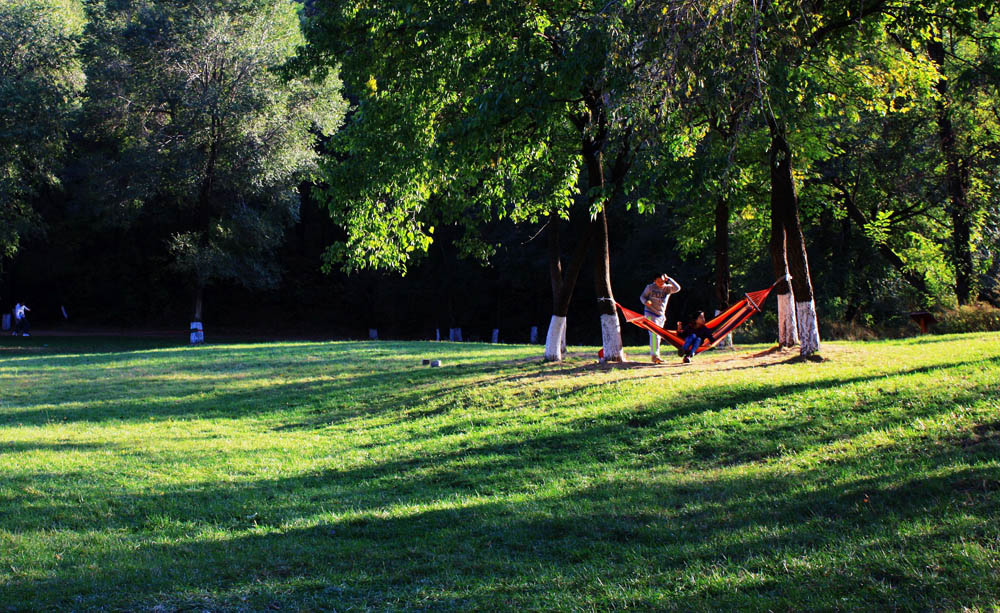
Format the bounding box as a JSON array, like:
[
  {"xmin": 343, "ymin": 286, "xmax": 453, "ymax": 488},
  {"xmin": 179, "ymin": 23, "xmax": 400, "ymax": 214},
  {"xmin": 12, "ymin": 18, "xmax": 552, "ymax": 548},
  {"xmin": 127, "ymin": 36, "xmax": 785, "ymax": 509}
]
[{"xmin": 0, "ymin": 334, "xmax": 1000, "ymax": 612}]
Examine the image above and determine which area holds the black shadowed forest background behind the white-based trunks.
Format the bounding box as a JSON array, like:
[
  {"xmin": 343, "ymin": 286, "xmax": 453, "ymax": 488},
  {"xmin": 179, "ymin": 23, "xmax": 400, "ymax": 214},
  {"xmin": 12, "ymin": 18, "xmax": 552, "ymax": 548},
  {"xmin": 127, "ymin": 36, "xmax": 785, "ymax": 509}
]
[{"xmin": 3, "ymin": 178, "xmax": 920, "ymax": 344}]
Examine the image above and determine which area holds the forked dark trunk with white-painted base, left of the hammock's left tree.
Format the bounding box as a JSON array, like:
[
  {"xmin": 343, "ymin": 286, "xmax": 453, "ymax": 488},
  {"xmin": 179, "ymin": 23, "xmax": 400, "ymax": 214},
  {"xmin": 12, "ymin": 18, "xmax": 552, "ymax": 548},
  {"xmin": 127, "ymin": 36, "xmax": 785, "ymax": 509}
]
[{"xmin": 545, "ymin": 211, "xmax": 593, "ymax": 362}]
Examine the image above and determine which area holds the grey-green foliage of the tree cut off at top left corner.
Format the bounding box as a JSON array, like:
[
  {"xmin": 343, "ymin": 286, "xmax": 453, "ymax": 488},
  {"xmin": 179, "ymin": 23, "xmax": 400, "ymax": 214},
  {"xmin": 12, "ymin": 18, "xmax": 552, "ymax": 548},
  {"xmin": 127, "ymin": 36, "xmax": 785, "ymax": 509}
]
[{"xmin": 0, "ymin": 0, "xmax": 83, "ymax": 256}]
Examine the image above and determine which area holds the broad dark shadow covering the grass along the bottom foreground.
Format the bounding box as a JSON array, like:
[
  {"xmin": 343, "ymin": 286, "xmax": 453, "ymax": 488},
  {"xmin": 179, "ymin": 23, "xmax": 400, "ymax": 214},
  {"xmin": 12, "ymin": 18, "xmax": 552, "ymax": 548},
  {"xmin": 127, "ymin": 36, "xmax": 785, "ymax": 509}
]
[{"xmin": 0, "ymin": 420, "xmax": 1000, "ymax": 611}]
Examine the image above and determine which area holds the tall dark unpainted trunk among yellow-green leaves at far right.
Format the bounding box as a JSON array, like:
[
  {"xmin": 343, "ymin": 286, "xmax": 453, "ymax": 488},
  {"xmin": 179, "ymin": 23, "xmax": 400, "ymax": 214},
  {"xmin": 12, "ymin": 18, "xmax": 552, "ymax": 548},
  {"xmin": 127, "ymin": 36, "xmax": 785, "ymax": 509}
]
[{"xmin": 927, "ymin": 41, "xmax": 973, "ymax": 304}]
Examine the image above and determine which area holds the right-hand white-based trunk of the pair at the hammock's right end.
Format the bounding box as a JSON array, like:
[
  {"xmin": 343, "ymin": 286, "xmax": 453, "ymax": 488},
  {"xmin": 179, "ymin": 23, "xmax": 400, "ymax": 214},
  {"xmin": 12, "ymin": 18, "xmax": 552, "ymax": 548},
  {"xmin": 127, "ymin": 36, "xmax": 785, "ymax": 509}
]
[{"xmin": 768, "ymin": 116, "xmax": 819, "ymax": 356}]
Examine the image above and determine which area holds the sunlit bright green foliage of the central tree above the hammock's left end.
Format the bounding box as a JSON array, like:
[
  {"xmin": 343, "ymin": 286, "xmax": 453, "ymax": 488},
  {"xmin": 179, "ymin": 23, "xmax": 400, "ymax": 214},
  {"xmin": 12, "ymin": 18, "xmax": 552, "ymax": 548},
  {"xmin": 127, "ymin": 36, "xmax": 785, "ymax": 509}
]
[{"xmin": 296, "ymin": 0, "xmax": 716, "ymax": 270}]
